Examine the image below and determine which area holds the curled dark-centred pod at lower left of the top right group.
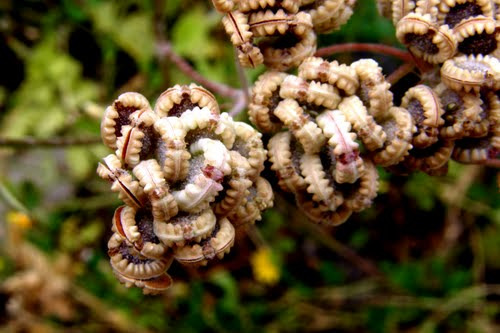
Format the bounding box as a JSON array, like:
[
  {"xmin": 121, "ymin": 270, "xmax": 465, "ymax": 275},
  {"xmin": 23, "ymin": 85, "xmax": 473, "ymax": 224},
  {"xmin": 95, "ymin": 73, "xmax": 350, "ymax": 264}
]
[{"xmin": 396, "ymin": 13, "xmax": 457, "ymax": 64}]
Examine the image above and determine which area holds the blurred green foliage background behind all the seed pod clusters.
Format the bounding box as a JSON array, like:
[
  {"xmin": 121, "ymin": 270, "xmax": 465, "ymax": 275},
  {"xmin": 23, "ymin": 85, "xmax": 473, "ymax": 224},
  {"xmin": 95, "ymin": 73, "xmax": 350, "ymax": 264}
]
[{"xmin": 0, "ymin": 0, "xmax": 500, "ymax": 332}]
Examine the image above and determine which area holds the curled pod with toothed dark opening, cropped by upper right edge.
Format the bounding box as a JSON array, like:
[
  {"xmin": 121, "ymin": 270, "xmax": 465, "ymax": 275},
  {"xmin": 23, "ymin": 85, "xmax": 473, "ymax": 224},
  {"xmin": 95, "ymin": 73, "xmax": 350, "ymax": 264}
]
[{"xmin": 453, "ymin": 16, "xmax": 500, "ymax": 55}]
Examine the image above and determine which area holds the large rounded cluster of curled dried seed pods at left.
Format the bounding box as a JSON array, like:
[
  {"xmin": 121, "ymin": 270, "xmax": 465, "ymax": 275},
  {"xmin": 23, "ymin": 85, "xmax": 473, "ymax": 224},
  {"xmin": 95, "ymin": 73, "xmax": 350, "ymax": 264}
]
[{"xmin": 97, "ymin": 84, "xmax": 273, "ymax": 293}]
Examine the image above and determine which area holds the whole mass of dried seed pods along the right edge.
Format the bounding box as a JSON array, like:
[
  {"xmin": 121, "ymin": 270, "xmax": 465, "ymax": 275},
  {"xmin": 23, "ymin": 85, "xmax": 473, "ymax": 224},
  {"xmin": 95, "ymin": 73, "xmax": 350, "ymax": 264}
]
[{"xmin": 378, "ymin": 0, "xmax": 500, "ymax": 174}]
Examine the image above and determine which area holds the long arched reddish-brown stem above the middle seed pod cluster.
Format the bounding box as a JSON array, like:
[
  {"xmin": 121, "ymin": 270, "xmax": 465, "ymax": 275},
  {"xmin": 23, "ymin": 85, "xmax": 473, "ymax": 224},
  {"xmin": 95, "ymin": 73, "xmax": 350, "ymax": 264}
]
[{"xmin": 315, "ymin": 43, "xmax": 413, "ymax": 62}]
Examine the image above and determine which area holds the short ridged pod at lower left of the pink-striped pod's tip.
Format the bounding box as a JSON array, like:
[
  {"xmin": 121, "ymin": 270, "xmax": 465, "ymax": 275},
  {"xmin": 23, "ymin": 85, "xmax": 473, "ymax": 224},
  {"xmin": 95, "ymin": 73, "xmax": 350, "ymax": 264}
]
[{"xmin": 300, "ymin": 154, "xmax": 342, "ymax": 211}]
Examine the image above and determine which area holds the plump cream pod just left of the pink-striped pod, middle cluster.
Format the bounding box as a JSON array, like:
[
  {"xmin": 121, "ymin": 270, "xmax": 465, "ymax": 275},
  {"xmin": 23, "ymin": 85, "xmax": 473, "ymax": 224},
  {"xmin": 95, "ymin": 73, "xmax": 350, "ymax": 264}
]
[{"xmin": 274, "ymin": 99, "xmax": 325, "ymax": 154}]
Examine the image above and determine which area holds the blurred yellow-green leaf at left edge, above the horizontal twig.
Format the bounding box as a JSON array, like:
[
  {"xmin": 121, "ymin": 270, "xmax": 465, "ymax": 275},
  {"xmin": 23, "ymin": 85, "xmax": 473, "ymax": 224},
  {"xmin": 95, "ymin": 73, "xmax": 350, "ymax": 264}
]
[{"xmin": 1, "ymin": 34, "xmax": 97, "ymax": 137}]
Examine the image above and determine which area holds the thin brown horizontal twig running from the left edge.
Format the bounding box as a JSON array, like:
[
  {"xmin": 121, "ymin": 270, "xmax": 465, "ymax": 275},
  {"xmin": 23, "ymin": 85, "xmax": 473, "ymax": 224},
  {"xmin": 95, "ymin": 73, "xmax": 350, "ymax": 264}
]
[{"xmin": 0, "ymin": 136, "xmax": 101, "ymax": 149}]
